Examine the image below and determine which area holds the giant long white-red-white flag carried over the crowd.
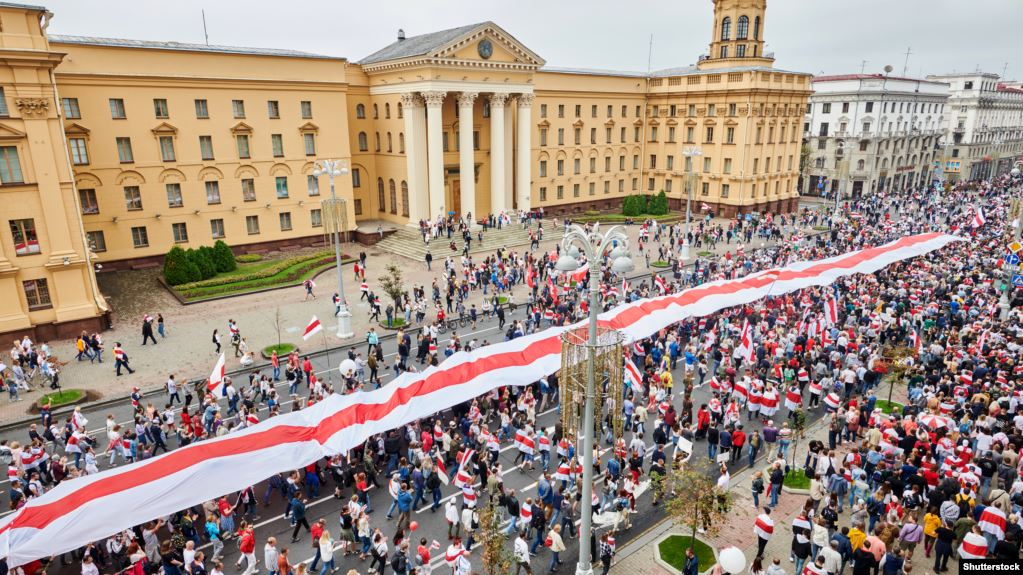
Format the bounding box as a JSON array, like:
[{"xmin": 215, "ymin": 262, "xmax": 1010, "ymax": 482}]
[{"xmin": 0, "ymin": 233, "xmax": 963, "ymax": 567}]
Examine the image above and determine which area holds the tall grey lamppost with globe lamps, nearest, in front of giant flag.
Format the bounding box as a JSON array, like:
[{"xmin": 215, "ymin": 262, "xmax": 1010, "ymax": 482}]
[{"xmin": 554, "ymin": 225, "xmax": 635, "ymax": 575}]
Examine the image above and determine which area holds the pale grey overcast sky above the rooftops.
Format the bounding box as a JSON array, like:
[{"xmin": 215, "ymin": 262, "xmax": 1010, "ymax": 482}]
[{"xmin": 37, "ymin": 0, "xmax": 1023, "ymax": 79}]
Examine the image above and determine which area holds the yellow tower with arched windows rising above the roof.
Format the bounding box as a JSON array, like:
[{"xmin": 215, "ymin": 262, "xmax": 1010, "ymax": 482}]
[{"xmin": 700, "ymin": 0, "xmax": 774, "ymax": 70}]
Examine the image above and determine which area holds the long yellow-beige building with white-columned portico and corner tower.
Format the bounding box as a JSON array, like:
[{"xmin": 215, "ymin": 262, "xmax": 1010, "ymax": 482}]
[{"xmin": 0, "ymin": 0, "xmax": 810, "ymax": 336}]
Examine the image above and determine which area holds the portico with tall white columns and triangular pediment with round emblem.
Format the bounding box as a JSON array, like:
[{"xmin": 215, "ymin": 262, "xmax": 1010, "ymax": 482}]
[{"xmin": 360, "ymin": 23, "xmax": 543, "ymax": 225}]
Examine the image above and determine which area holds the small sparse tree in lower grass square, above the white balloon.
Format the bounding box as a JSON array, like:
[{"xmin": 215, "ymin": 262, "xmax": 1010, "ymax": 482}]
[{"xmin": 664, "ymin": 468, "xmax": 730, "ymax": 546}]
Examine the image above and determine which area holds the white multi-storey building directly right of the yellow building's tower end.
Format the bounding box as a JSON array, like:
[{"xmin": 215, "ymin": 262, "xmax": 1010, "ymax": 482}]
[{"xmin": 802, "ymin": 74, "xmax": 948, "ymax": 196}]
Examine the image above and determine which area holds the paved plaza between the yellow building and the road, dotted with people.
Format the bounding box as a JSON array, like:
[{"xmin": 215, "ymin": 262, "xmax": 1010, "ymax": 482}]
[{"xmin": 0, "ymin": 209, "xmax": 826, "ymax": 428}]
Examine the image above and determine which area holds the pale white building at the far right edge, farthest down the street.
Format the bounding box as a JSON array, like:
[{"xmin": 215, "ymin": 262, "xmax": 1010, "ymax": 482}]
[{"xmin": 927, "ymin": 72, "xmax": 1023, "ymax": 180}]
